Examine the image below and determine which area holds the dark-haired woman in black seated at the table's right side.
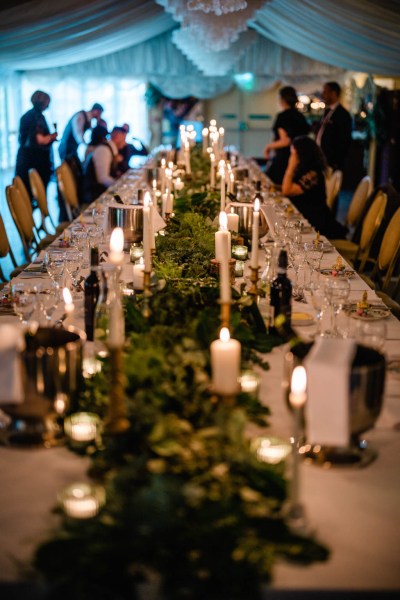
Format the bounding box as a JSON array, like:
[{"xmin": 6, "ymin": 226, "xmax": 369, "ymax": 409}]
[{"xmin": 282, "ymin": 136, "xmax": 347, "ymax": 239}]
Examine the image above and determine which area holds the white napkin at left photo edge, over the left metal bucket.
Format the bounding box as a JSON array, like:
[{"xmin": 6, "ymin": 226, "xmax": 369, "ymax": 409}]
[{"xmin": 0, "ymin": 323, "xmax": 24, "ymax": 404}]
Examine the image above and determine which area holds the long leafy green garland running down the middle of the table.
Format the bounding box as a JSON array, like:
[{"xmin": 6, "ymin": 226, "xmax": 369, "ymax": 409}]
[{"xmin": 34, "ymin": 145, "xmax": 328, "ymax": 600}]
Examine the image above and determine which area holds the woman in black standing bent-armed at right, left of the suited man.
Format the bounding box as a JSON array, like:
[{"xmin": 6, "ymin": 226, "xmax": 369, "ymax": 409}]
[{"xmin": 264, "ymin": 86, "xmax": 310, "ymax": 184}]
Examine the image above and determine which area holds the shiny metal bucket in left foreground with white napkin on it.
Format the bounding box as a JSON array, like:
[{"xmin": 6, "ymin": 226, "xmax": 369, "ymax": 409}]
[{"xmin": 3, "ymin": 327, "xmax": 86, "ymax": 446}]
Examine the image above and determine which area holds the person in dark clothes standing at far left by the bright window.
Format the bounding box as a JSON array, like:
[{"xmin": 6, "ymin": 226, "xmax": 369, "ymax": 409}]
[{"xmin": 15, "ymin": 90, "xmax": 57, "ymax": 197}]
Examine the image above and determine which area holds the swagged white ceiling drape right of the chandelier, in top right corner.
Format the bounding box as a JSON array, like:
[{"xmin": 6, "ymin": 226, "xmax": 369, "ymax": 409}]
[{"xmin": 252, "ymin": 0, "xmax": 400, "ymax": 76}]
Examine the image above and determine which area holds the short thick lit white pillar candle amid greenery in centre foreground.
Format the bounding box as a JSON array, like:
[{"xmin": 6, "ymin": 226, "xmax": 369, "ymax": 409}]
[{"xmin": 210, "ymin": 327, "xmax": 241, "ymax": 395}]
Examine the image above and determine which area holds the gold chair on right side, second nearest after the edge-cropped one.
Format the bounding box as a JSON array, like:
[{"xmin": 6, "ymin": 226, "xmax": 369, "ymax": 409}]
[{"xmin": 331, "ymin": 190, "xmax": 388, "ymax": 272}]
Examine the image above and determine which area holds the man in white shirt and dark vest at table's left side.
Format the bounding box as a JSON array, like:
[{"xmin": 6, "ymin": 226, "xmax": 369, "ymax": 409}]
[{"xmin": 84, "ymin": 125, "xmax": 126, "ymax": 203}]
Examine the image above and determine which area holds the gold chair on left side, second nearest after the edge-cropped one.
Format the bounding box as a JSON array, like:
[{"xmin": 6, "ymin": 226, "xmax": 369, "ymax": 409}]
[{"xmin": 6, "ymin": 185, "xmax": 55, "ymax": 262}]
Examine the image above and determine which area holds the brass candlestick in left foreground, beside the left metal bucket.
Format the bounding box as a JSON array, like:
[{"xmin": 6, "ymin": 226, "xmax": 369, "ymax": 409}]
[{"xmin": 104, "ymin": 348, "xmax": 130, "ymax": 435}]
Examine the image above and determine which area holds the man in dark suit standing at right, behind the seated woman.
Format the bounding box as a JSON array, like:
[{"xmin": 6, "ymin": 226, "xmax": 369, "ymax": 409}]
[{"xmin": 316, "ymin": 81, "xmax": 352, "ymax": 171}]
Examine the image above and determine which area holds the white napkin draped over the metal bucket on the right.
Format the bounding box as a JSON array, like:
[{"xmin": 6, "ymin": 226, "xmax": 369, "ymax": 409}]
[{"xmin": 304, "ymin": 337, "xmax": 356, "ymax": 447}]
